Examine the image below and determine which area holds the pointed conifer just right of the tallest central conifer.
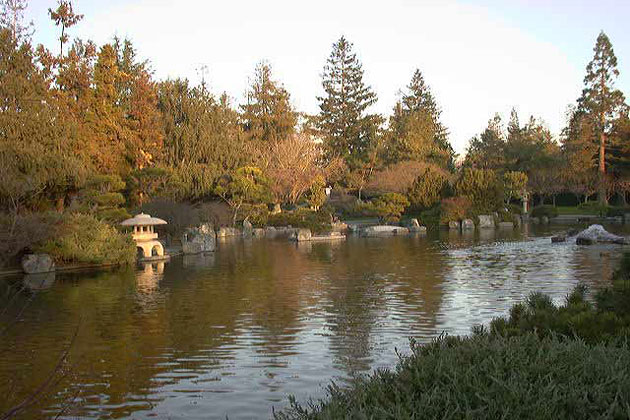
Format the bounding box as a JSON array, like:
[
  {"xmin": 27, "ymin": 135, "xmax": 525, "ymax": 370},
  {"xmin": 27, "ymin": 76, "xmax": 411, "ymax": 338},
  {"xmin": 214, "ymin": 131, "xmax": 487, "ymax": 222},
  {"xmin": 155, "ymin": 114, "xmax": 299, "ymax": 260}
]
[{"xmin": 386, "ymin": 70, "xmax": 455, "ymax": 168}]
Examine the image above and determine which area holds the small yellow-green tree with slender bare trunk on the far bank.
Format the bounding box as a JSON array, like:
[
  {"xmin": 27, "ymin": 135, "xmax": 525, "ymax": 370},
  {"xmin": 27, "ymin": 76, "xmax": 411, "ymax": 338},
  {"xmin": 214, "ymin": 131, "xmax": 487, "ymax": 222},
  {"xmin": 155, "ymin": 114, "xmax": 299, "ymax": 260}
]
[{"xmin": 215, "ymin": 166, "xmax": 269, "ymax": 226}]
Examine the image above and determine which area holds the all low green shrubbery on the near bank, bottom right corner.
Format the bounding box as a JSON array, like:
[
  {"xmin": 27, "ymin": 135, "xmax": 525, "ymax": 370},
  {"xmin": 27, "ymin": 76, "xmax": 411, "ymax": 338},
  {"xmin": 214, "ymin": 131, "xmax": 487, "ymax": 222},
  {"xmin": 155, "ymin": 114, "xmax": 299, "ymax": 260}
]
[{"xmin": 276, "ymin": 255, "xmax": 630, "ymax": 419}]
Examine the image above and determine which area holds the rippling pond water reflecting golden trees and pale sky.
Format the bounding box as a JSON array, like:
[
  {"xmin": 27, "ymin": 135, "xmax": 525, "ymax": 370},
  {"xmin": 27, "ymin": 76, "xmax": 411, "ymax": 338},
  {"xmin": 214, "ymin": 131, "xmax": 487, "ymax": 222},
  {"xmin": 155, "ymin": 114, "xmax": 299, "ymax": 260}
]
[{"xmin": 0, "ymin": 228, "xmax": 623, "ymax": 419}]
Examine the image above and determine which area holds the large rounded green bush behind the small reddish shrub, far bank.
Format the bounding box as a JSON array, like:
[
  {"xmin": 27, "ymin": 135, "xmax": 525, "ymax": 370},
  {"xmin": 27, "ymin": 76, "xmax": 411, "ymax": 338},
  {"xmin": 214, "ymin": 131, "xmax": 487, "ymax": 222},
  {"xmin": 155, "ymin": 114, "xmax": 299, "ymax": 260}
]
[{"xmin": 455, "ymin": 168, "xmax": 504, "ymax": 214}]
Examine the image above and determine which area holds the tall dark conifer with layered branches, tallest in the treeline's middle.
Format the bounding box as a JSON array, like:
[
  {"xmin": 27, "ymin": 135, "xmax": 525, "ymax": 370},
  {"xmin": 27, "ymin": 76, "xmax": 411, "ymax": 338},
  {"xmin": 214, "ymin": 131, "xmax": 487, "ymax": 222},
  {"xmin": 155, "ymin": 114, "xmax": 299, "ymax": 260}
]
[{"xmin": 317, "ymin": 36, "xmax": 381, "ymax": 170}]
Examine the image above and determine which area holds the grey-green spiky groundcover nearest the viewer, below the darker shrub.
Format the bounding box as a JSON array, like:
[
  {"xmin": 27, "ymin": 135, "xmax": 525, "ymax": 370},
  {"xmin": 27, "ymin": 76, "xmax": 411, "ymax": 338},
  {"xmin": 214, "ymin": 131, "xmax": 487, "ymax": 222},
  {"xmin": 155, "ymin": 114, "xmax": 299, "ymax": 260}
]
[{"xmin": 276, "ymin": 332, "xmax": 630, "ymax": 419}]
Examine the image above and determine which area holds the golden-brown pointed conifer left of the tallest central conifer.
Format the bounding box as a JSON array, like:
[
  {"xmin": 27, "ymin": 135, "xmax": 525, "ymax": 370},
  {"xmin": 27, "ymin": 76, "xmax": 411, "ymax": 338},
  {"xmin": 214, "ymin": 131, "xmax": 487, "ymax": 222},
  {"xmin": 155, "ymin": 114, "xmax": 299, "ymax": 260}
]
[{"xmin": 241, "ymin": 62, "xmax": 297, "ymax": 142}]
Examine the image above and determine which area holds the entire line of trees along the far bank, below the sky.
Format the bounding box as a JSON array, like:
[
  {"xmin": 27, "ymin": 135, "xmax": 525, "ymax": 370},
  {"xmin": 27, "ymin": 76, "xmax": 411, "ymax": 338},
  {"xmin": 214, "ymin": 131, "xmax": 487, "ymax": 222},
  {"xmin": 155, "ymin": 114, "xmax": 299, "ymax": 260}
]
[{"xmin": 0, "ymin": 0, "xmax": 630, "ymax": 230}]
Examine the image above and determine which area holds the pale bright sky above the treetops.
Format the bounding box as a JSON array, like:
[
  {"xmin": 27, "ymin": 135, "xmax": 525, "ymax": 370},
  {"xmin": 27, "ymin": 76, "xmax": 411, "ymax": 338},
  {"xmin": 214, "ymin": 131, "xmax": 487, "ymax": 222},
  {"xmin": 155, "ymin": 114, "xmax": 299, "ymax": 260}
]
[{"xmin": 26, "ymin": 0, "xmax": 630, "ymax": 154}]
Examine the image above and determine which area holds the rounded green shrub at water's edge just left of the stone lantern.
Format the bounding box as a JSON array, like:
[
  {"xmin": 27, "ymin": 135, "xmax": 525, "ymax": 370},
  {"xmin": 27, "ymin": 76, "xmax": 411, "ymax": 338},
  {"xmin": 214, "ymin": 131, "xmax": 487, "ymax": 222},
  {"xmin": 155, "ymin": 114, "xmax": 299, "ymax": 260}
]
[{"xmin": 39, "ymin": 214, "xmax": 136, "ymax": 264}]
